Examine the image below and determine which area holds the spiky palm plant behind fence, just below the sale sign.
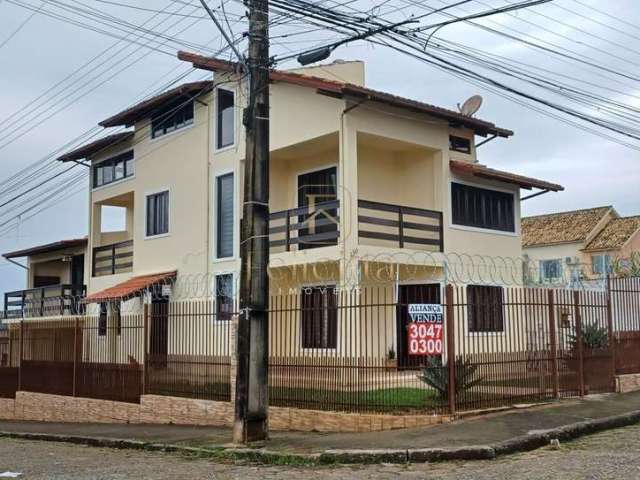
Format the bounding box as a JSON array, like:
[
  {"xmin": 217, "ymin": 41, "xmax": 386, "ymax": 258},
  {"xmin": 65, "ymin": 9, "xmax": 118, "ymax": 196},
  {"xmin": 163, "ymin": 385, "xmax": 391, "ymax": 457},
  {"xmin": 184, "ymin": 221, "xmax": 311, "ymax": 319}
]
[{"xmin": 418, "ymin": 357, "xmax": 484, "ymax": 399}]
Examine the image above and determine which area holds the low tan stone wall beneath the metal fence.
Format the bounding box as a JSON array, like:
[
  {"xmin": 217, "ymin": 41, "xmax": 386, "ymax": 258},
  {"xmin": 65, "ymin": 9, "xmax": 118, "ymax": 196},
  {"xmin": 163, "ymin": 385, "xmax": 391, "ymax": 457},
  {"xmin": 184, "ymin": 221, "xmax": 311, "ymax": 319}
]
[{"xmin": 0, "ymin": 392, "xmax": 448, "ymax": 432}]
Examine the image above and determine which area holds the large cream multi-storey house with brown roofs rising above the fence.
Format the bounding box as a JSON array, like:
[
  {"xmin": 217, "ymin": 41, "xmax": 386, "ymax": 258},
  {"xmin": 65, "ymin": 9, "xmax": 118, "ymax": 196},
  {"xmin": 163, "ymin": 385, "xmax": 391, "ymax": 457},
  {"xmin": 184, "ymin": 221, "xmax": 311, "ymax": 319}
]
[{"xmin": 5, "ymin": 54, "xmax": 562, "ymax": 362}]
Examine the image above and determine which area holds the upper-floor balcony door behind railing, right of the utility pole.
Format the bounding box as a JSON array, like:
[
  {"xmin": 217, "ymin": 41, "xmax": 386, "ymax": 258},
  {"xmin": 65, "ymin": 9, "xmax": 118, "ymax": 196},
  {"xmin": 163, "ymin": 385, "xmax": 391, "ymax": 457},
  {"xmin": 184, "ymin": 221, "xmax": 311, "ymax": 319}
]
[{"xmin": 298, "ymin": 167, "xmax": 338, "ymax": 250}]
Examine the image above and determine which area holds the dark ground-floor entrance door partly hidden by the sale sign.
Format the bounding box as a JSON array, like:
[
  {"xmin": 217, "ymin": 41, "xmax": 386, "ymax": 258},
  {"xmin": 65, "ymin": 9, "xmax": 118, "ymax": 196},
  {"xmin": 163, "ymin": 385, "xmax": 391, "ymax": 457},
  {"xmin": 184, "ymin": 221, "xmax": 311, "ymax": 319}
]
[{"xmin": 396, "ymin": 283, "xmax": 441, "ymax": 368}]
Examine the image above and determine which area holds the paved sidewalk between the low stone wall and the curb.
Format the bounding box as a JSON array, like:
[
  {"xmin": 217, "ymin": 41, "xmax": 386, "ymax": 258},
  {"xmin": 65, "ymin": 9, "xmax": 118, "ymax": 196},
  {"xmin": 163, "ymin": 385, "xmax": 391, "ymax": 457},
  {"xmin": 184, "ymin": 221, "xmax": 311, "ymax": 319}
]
[{"xmin": 0, "ymin": 392, "xmax": 640, "ymax": 453}]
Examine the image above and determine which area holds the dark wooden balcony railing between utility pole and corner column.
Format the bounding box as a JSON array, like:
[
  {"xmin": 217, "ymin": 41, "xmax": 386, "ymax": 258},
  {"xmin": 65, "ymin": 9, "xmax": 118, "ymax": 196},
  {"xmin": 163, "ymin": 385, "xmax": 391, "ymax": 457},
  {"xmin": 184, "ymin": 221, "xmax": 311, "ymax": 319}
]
[{"xmin": 269, "ymin": 200, "xmax": 340, "ymax": 252}]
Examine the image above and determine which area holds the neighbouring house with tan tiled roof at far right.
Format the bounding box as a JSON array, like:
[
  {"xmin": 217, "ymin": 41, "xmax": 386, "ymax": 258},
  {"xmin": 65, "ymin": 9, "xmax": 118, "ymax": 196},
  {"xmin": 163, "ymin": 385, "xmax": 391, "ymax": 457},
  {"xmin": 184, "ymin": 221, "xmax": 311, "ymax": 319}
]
[{"xmin": 522, "ymin": 206, "xmax": 640, "ymax": 284}]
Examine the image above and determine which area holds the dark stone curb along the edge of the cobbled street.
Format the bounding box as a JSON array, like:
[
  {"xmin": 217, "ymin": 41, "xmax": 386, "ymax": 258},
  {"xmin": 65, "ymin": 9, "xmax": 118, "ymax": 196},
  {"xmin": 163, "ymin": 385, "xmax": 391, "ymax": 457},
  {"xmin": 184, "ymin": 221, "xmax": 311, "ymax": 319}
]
[{"xmin": 0, "ymin": 410, "xmax": 640, "ymax": 465}]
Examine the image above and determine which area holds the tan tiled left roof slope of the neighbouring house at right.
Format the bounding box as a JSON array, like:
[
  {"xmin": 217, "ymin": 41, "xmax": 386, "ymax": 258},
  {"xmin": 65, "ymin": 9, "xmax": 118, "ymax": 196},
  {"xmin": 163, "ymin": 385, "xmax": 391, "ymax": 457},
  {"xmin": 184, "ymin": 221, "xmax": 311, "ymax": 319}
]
[{"xmin": 522, "ymin": 207, "xmax": 613, "ymax": 247}]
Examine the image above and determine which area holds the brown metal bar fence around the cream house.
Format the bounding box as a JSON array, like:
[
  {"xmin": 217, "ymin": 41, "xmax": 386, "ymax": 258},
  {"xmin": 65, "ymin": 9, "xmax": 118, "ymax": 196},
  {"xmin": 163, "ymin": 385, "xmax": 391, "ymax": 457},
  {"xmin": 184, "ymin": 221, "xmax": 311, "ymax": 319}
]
[{"xmin": 0, "ymin": 278, "xmax": 640, "ymax": 414}]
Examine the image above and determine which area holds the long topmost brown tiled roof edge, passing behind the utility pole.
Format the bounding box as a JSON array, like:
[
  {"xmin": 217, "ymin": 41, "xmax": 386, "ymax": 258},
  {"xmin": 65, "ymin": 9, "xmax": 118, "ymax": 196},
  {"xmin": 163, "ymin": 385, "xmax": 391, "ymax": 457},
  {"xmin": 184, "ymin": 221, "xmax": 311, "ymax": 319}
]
[{"xmin": 178, "ymin": 52, "xmax": 513, "ymax": 137}]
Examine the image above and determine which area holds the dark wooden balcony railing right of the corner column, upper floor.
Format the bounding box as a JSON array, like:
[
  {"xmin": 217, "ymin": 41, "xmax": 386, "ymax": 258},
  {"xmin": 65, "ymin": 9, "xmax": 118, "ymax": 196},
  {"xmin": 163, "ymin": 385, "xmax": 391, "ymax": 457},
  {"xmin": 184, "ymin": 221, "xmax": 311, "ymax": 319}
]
[{"xmin": 358, "ymin": 200, "xmax": 444, "ymax": 252}]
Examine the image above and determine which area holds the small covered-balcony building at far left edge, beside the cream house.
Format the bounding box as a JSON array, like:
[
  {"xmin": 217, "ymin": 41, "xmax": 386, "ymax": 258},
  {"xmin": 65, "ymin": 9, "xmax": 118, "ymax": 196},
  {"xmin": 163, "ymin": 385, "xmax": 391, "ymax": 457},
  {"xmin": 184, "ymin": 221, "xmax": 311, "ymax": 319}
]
[{"xmin": 2, "ymin": 238, "xmax": 87, "ymax": 318}]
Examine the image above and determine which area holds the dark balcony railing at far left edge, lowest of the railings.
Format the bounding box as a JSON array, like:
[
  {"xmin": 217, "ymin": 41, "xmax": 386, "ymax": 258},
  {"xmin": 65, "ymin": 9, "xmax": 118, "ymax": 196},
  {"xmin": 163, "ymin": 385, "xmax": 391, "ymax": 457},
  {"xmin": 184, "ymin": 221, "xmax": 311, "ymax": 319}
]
[{"xmin": 4, "ymin": 284, "xmax": 87, "ymax": 318}]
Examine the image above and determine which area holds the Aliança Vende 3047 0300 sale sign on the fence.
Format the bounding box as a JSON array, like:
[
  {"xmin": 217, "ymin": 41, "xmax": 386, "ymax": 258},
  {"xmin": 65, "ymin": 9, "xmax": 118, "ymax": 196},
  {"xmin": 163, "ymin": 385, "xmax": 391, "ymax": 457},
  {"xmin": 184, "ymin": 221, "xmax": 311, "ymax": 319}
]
[{"xmin": 408, "ymin": 303, "xmax": 443, "ymax": 356}]
